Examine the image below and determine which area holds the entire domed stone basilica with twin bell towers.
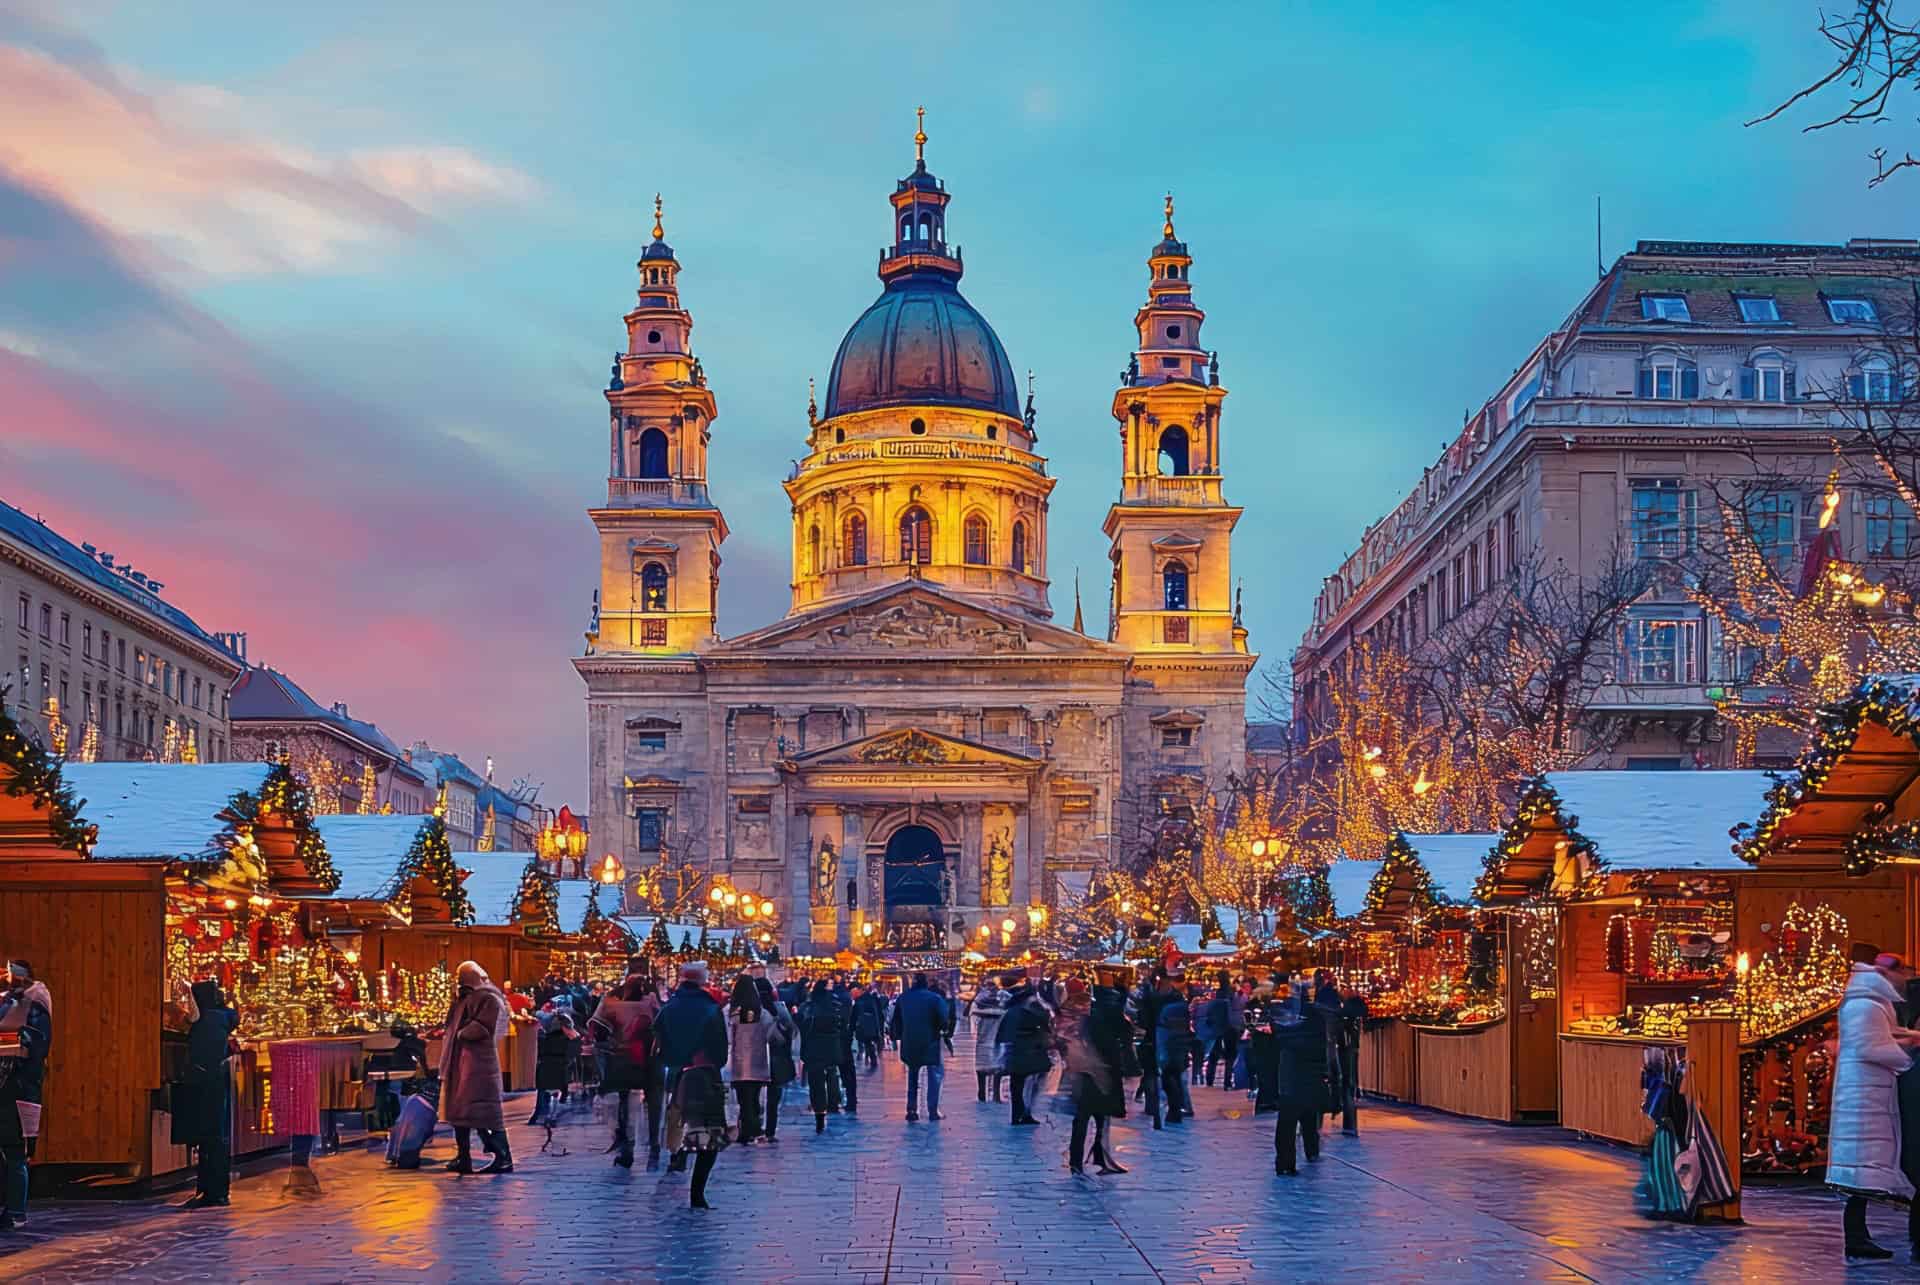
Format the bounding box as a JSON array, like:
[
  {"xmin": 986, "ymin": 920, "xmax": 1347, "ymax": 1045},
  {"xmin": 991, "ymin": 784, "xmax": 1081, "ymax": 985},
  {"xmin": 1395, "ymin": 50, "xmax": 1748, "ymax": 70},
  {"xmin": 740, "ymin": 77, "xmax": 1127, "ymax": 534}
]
[{"xmin": 574, "ymin": 129, "xmax": 1254, "ymax": 953}]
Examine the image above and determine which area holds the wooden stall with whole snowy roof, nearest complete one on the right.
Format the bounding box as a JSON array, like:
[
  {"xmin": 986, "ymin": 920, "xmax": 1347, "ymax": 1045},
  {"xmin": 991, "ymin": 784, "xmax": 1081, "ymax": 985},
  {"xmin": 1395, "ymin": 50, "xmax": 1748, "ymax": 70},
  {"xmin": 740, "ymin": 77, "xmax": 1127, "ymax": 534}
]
[{"xmin": 1486, "ymin": 770, "xmax": 1766, "ymax": 1145}]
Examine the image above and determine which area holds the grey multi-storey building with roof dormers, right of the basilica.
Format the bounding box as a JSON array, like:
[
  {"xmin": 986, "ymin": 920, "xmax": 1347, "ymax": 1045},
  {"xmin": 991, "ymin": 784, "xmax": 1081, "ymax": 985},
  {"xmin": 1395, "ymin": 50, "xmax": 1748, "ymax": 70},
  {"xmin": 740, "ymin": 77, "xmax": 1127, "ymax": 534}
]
[{"xmin": 1292, "ymin": 238, "xmax": 1920, "ymax": 768}]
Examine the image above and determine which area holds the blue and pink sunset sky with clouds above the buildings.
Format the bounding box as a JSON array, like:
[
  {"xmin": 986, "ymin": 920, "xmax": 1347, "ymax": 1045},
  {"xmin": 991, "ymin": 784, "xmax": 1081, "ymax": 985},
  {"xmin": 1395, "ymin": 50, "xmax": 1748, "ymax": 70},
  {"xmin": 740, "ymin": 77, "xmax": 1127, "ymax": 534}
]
[{"xmin": 0, "ymin": 0, "xmax": 1889, "ymax": 803}]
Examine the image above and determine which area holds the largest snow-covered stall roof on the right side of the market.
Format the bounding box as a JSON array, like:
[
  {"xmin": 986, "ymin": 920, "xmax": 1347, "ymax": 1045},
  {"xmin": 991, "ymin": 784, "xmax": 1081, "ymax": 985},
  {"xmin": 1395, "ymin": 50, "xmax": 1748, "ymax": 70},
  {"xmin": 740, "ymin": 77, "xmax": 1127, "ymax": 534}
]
[{"xmin": 1546, "ymin": 770, "xmax": 1772, "ymax": 870}]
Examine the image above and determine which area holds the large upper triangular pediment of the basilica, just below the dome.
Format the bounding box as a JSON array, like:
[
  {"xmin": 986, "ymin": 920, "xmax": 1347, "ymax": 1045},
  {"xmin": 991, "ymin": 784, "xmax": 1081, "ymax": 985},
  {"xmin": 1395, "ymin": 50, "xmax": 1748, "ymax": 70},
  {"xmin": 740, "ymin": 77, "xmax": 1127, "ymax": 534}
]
[{"xmin": 705, "ymin": 580, "xmax": 1127, "ymax": 657}]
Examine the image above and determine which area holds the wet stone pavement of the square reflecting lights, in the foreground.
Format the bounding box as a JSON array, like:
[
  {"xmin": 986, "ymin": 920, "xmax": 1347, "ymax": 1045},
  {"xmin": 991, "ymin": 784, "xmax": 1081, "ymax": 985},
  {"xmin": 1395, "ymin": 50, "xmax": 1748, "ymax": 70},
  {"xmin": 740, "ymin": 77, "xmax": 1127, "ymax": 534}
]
[{"xmin": 0, "ymin": 1043, "xmax": 1914, "ymax": 1285}]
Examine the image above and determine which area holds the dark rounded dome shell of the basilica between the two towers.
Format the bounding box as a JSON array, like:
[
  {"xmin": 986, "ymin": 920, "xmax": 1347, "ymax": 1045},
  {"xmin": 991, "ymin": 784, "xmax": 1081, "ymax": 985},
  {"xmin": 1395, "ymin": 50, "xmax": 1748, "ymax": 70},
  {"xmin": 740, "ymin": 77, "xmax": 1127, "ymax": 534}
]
[{"xmin": 826, "ymin": 273, "xmax": 1020, "ymax": 419}]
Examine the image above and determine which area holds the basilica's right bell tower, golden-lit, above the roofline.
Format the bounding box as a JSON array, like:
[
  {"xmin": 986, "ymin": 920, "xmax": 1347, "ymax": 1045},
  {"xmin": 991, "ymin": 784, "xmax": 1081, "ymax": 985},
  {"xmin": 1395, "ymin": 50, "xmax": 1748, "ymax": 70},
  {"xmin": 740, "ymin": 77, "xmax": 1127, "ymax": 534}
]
[{"xmin": 1102, "ymin": 194, "xmax": 1246, "ymax": 655}]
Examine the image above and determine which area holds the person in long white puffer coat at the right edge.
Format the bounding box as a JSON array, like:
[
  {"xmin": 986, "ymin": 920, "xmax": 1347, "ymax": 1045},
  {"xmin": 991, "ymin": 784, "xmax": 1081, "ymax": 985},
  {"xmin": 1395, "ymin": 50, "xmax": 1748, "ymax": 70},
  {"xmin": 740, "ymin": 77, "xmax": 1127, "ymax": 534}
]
[{"xmin": 1826, "ymin": 955, "xmax": 1920, "ymax": 1258}]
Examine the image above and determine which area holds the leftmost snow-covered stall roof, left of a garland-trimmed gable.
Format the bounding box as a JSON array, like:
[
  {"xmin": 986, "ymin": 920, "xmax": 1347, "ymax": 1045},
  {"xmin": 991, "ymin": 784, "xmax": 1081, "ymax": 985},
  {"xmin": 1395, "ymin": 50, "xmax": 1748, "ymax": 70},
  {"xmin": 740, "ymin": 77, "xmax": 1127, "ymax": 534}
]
[{"xmin": 60, "ymin": 763, "xmax": 269, "ymax": 861}]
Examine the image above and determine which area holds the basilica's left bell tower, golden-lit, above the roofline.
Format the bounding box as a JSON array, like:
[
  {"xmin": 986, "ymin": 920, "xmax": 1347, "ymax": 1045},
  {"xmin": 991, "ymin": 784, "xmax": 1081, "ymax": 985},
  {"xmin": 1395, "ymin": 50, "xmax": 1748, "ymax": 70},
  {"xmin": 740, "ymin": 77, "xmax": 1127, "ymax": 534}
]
[{"xmin": 588, "ymin": 196, "xmax": 728, "ymax": 655}]
